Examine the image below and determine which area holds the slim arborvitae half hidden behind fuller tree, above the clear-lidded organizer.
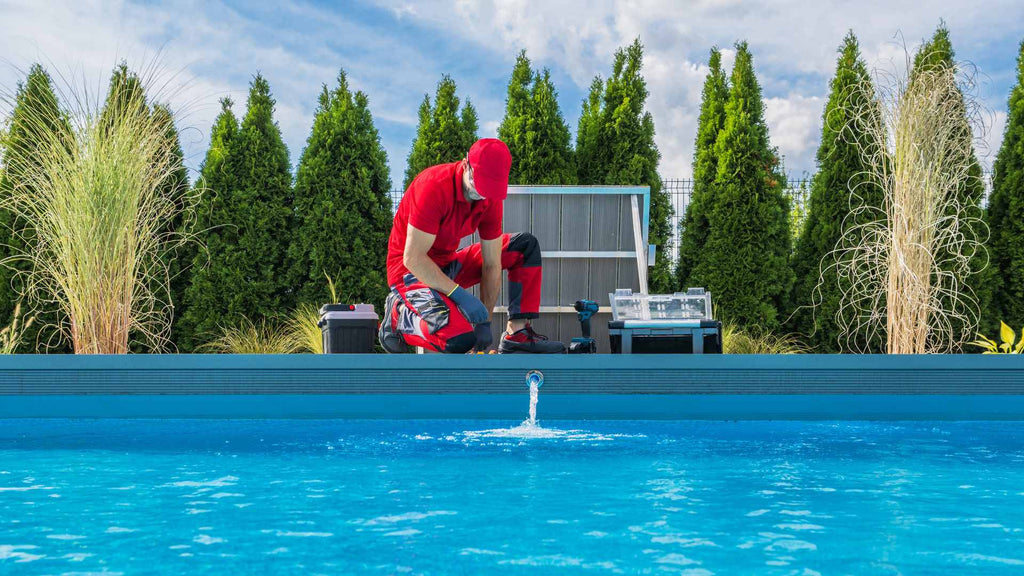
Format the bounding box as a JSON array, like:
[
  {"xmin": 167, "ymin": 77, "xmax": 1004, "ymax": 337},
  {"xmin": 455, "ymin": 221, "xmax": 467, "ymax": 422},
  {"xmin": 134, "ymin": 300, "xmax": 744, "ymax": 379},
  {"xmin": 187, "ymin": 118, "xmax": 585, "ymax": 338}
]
[{"xmin": 676, "ymin": 47, "xmax": 729, "ymax": 289}]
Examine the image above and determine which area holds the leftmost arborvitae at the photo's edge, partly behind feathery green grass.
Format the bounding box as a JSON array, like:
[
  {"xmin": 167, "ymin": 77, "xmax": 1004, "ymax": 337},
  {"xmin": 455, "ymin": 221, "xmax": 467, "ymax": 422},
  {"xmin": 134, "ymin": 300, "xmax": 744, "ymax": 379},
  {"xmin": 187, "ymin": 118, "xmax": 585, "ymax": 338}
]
[{"xmin": 0, "ymin": 65, "xmax": 71, "ymax": 353}]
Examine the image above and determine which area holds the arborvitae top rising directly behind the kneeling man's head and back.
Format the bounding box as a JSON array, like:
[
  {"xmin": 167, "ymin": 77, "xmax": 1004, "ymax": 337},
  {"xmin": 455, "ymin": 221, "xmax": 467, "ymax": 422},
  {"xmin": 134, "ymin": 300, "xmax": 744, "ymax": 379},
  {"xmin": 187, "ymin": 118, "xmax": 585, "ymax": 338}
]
[{"xmin": 402, "ymin": 76, "xmax": 478, "ymax": 188}]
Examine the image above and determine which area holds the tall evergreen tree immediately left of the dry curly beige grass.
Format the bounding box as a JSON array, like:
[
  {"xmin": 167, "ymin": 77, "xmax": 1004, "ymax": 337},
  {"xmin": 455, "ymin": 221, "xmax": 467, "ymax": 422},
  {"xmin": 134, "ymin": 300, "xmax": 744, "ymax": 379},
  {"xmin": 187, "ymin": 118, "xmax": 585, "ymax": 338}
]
[{"xmin": 787, "ymin": 32, "xmax": 883, "ymax": 353}]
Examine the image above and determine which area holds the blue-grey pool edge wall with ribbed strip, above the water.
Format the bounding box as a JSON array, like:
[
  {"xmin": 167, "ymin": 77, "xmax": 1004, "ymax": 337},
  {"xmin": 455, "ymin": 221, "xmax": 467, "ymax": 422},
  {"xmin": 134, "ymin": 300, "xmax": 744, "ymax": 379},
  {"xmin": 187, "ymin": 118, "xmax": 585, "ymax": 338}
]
[{"xmin": 0, "ymin": 355, "xmax": 1024, "ymax": 420}]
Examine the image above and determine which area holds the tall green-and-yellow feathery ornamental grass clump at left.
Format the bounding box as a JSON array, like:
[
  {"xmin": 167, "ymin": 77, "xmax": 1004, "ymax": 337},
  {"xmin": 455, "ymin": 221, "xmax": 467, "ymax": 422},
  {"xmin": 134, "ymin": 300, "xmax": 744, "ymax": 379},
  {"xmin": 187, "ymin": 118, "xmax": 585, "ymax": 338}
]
[{"xmin": 0, "ymin": 71, "xmax": 194, "ymax": 354}]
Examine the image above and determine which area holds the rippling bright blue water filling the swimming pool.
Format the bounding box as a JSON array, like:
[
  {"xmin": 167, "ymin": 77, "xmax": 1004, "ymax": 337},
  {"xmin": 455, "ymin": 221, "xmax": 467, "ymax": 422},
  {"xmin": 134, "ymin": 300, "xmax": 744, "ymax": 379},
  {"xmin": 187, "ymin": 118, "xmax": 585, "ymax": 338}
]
[{"xmin": 0, "ymin": 420, "xmax": 1024, "ymax": 575}]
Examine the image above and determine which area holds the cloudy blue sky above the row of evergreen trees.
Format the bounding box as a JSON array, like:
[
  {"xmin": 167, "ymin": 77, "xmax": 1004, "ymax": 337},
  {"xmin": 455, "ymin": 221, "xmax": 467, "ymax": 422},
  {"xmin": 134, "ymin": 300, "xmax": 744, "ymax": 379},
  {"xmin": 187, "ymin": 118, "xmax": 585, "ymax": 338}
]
[{"xmin": 0, "ymin": 0, "xmax": 1024, "ymax": 188}]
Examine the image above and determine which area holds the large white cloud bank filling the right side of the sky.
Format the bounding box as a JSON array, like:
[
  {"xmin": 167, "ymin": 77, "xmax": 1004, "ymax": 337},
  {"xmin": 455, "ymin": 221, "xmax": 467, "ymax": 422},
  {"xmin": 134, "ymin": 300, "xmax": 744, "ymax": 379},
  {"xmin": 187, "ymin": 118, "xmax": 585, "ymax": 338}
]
[{"xmin": 377, "ymin": 0, "xmax": 1024, "ymax": 176}]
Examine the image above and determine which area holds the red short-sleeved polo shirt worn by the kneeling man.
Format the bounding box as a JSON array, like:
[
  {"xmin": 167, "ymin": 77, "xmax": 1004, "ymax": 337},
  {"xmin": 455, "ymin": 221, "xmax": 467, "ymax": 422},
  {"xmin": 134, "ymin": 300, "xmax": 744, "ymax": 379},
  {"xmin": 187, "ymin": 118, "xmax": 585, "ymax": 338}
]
[{"xmin": 387, "ymin": 161, "xmax": 503, "ymax": 286}]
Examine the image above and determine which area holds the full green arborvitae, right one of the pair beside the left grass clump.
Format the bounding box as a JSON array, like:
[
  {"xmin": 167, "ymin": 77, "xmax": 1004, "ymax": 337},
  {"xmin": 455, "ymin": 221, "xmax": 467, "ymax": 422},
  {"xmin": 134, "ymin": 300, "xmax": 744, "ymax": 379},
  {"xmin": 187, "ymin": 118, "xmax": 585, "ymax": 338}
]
[{"xmin": 184, "ymin": 75, "xmax": 294, "ymax": 341}]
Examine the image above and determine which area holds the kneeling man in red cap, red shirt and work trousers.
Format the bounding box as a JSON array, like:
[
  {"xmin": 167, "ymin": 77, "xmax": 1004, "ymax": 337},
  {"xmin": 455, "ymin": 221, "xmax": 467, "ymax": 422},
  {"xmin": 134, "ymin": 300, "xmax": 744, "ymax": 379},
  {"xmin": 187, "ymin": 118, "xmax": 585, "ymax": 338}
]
[{"xmin": 379, "ymin": 138, "xmax": 565, "ymax": 354}]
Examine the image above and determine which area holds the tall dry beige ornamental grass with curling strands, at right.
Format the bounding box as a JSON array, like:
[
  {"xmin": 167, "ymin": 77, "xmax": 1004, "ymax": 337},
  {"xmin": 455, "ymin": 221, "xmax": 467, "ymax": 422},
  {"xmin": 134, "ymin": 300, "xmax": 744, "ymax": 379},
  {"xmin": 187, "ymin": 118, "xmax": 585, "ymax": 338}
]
[{"xmin": 822, "ymin": 51, "xmax": 985, "ymax": 354}]
